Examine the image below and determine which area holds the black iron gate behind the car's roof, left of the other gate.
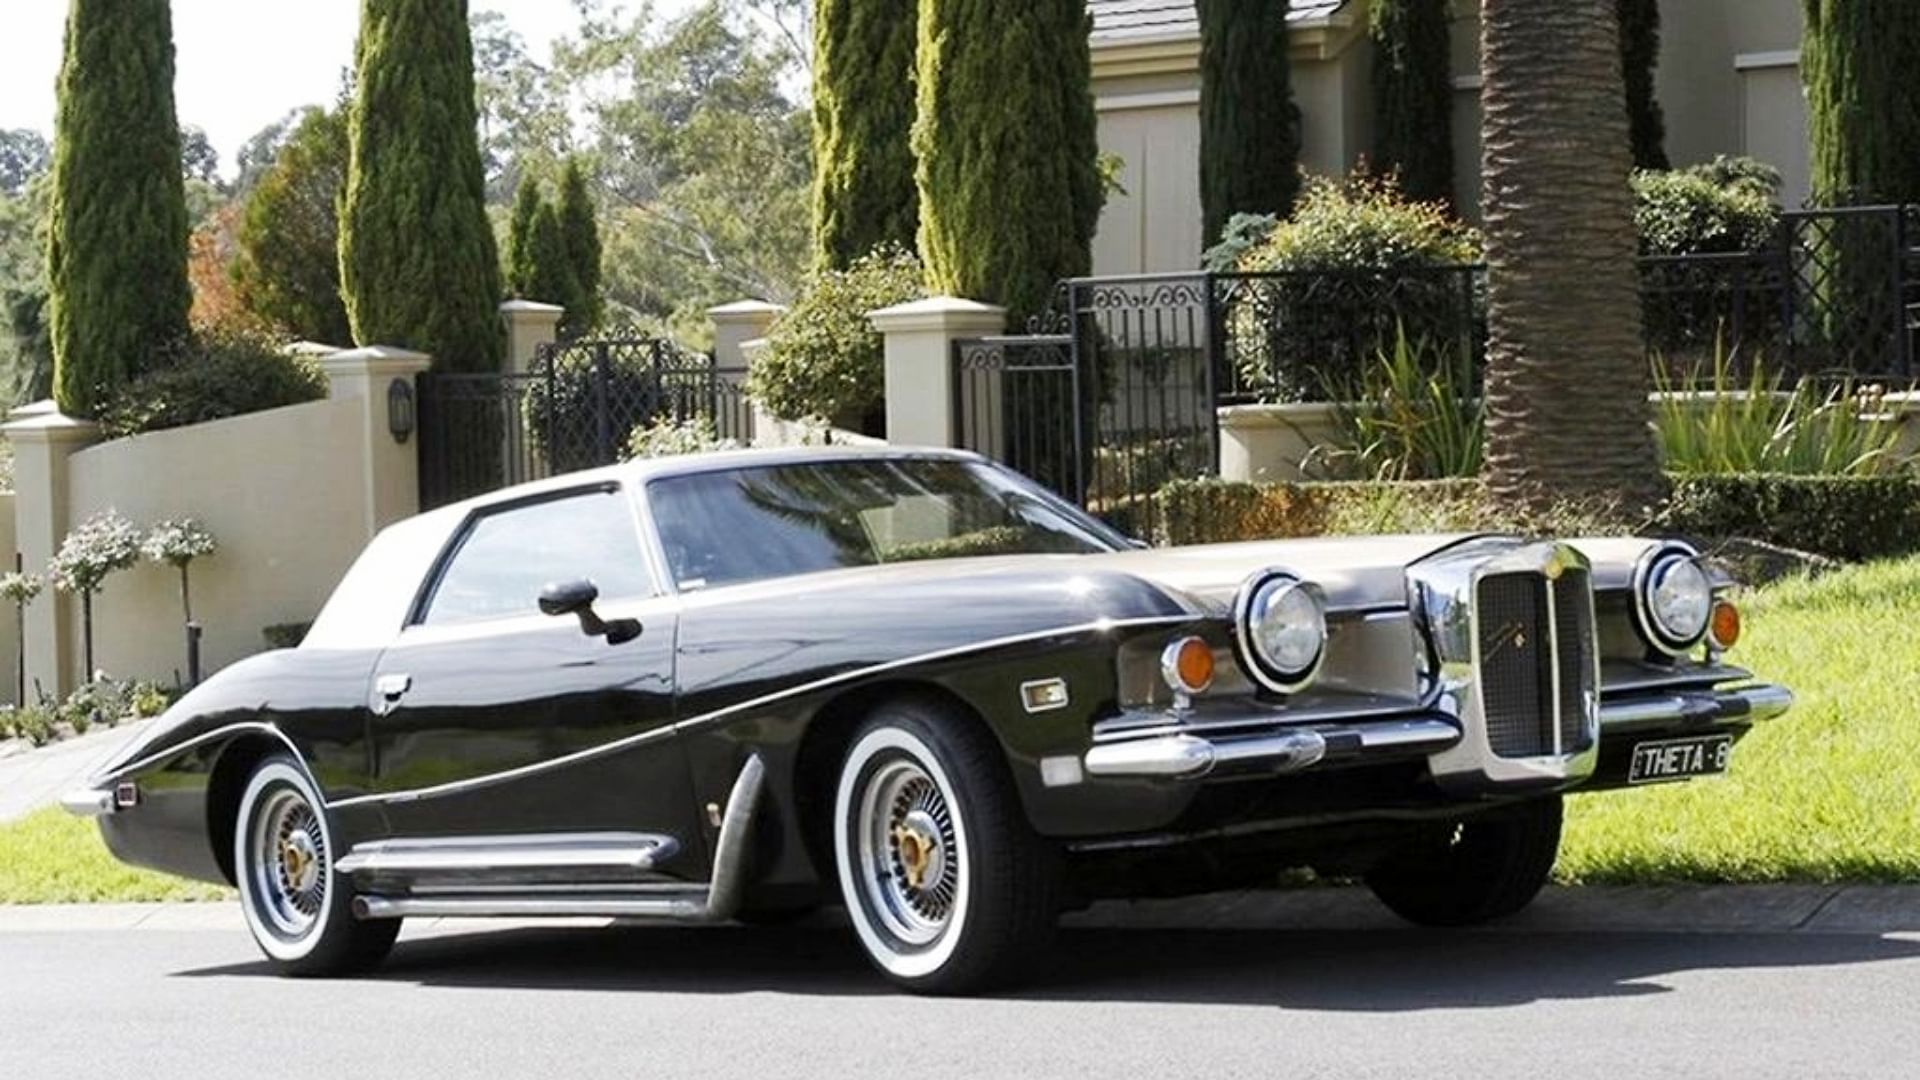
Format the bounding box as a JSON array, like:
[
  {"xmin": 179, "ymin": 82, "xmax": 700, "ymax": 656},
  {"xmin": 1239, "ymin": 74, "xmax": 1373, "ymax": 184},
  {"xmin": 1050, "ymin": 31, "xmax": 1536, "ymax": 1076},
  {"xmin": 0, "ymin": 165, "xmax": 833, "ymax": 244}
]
[{"xmin": 419, "ymin": 336, "xmax": 753, "ymax": 509}]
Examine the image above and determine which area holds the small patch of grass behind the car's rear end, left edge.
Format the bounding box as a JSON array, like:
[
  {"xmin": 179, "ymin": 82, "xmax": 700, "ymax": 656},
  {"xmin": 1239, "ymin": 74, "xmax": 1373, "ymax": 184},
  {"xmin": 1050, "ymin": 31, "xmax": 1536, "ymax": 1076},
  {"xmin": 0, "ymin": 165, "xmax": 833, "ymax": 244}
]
[{"xmin": 0, "ymin": 807, "xmax": 228, "ymax": 903}]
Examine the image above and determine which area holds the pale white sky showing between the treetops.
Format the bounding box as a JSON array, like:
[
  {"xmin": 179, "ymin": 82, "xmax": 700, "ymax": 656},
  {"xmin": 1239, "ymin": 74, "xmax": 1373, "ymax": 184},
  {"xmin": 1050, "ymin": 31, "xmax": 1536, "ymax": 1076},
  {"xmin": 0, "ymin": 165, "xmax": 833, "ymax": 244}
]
[{"xmin": 0, "ymin": 0, "xmax": 687, "ymax": 173}]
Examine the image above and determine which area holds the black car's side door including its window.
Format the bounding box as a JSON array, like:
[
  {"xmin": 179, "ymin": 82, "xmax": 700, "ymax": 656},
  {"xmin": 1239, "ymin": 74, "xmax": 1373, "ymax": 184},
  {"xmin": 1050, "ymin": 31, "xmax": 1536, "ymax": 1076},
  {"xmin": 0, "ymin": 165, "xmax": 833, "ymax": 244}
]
[{"xmin": 371, "ymin": 484, "xmax": 701, "ymax": 846}]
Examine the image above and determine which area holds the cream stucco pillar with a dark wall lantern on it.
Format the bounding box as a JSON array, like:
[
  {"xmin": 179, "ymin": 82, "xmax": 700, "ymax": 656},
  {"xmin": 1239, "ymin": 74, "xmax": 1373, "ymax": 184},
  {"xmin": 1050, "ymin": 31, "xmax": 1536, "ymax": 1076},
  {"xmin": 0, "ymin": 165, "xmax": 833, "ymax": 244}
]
[{"xmin": 319, "ymin": 346, "xmax": 432, "ymax": 540}]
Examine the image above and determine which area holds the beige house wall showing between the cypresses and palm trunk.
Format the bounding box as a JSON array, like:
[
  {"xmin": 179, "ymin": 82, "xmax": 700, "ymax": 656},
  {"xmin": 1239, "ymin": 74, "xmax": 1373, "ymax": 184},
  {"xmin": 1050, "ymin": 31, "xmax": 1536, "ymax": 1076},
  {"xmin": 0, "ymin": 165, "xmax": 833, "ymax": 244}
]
[{"xmin": 1094, "ymin": 0, "xmax": 1811, "ymax": 267}]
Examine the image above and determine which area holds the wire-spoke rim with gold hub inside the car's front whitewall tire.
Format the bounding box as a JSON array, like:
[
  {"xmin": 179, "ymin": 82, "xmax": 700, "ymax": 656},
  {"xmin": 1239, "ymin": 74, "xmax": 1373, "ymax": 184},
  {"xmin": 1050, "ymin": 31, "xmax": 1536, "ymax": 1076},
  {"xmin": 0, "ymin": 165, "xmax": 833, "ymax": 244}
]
[{"xmin": 854, "ymin": 757, "xmax": 966, "ymax": 945}]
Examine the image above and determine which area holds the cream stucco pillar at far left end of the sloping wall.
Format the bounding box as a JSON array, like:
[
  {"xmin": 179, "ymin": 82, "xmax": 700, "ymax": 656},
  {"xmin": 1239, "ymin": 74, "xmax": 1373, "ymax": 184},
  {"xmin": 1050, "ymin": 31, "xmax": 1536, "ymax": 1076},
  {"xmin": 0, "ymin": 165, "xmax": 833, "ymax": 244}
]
[{"xmin": 0, "ymin": 402, "xmax": 100, "ymax": 701}]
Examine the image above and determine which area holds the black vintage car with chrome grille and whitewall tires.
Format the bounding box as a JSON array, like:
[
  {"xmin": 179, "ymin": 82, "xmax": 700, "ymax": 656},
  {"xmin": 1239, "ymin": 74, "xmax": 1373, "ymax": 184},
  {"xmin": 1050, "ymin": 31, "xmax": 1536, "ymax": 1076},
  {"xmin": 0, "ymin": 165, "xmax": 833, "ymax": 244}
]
[{"xmin": 67, "ymin": 450, "xmax": 1791, "ymax": 992}]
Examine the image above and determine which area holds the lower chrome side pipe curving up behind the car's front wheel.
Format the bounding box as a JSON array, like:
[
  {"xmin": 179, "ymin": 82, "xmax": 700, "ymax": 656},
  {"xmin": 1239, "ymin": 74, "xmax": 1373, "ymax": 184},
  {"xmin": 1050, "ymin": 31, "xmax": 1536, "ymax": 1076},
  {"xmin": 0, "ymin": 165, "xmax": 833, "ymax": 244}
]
[{"xmin": 342, "ymin": 755, "xmax": 766, "ymax": 922}]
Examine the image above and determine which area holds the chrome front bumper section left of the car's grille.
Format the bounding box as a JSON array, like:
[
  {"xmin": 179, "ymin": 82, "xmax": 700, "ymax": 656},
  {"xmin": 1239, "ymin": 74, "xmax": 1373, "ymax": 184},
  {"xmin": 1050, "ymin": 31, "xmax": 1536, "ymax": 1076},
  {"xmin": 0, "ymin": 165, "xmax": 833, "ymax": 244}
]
[{"xmin": 1085, "ymin": 715, "xmax": 1461, "ymax": 780}]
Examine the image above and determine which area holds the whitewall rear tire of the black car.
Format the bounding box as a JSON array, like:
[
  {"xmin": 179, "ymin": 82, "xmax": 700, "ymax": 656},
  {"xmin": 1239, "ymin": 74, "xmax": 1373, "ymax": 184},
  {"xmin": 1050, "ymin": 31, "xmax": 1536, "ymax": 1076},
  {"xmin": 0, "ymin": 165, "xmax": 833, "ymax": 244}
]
[{"xmin": 234, "ymin": 755, "xmax": 399, "ymax": 974}]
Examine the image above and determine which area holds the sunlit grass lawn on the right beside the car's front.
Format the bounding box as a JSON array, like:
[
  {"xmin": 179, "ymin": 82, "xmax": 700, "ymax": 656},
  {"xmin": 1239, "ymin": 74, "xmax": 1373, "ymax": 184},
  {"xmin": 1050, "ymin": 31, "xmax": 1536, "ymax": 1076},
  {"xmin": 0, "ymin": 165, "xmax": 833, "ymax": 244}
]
[{"xmin": 1559, "ymin": 559, "xmax": 1920, "ymax": 882}]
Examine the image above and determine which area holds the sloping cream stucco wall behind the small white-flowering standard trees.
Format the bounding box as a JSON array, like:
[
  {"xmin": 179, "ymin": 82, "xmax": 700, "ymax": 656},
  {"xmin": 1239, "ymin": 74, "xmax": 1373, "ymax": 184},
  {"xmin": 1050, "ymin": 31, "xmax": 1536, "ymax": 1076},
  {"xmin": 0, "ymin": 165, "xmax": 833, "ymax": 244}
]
[{"xmin": 66, "ymin": 398, "xmax": 371, "ymax": 682}]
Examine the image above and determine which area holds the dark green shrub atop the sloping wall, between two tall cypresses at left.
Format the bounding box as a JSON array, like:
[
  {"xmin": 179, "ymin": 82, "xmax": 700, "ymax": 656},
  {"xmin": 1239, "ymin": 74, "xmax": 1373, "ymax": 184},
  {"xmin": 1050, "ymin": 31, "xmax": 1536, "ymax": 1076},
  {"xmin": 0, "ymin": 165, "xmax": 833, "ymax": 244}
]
[{"xmin": 100, "ymin": 332, "xmax": 326, "ymax": 438}]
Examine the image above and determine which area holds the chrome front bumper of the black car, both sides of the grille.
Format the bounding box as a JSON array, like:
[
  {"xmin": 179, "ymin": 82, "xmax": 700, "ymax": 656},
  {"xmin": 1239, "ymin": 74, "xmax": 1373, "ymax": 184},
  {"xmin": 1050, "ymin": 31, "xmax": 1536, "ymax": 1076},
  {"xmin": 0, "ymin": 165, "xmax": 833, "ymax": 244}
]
[{"xmin": 1085, "ymin": 686, "xmax": 1793, "ymax": 780}]
